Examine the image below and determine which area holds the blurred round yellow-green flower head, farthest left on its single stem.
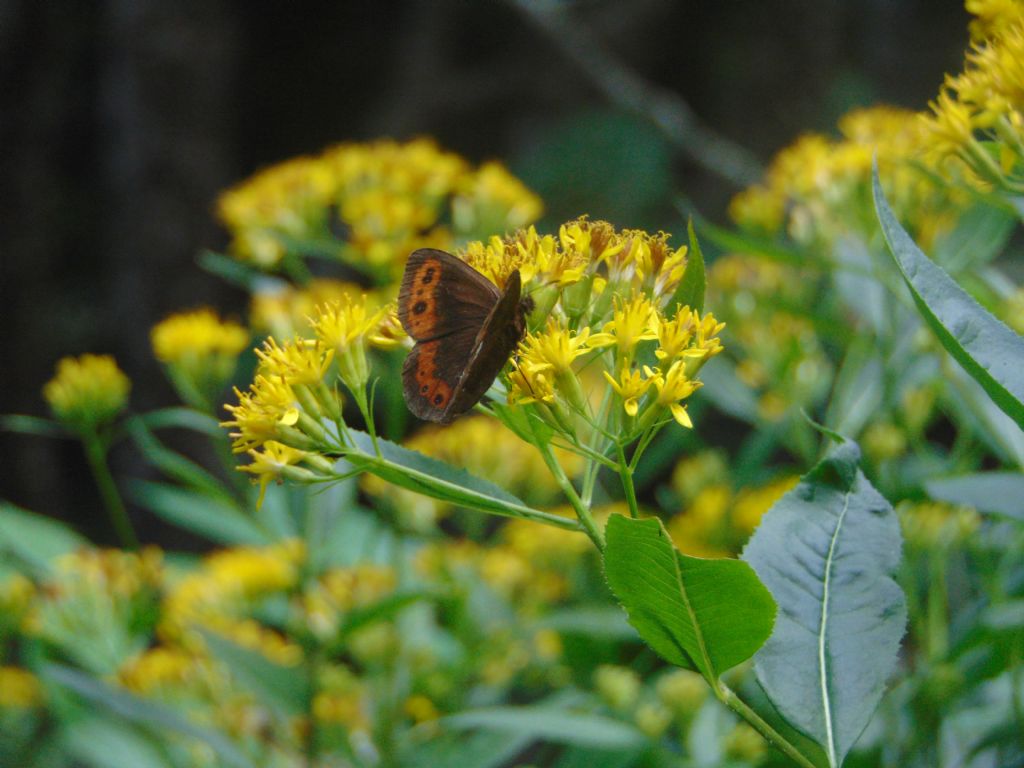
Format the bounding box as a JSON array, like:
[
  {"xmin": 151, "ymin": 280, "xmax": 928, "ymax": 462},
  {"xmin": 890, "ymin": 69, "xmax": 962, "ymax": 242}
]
[{"xmin": 43, "ymin": 354, "xmax": 131, "ymax": 430}]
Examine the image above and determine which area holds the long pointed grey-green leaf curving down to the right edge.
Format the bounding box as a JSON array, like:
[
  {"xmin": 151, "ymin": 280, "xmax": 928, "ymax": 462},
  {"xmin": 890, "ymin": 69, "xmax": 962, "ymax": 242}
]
[{"xmin": 872, "ymin": 168, "xmax": 1024, "ymax": 429}]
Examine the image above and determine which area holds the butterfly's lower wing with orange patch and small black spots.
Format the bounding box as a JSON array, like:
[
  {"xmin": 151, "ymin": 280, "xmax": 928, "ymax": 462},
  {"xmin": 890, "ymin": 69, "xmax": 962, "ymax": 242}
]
[{"xmin": 401, "ymin": 330, "xmax": 476, "ymax": 421}]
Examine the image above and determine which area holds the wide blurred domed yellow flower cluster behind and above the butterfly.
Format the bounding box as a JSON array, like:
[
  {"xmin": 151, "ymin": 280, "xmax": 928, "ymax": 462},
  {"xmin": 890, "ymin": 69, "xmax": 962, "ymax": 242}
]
[{"xmin": 218, "ymin": 138, "xmax": 542, "ymax": 281}]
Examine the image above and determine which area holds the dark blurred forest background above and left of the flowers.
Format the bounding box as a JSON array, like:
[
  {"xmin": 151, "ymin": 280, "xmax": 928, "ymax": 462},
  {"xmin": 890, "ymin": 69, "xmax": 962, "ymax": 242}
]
[{"xmin": 0, "ymin": 0, "xmax": 968, "ymax": 542}]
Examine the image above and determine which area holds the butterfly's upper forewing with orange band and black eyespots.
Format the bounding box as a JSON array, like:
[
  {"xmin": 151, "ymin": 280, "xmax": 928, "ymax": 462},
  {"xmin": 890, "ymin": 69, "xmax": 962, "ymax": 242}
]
[{"xmin": 398, "ymin": 248, "xmax": 502, "ymax": 342}]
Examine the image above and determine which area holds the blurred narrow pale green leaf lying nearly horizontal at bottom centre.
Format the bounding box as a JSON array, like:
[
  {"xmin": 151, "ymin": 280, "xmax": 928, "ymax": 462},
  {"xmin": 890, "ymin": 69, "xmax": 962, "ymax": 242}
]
[{"xmin": 440, "ymin": 705, "xmax": 646, "ymax": 750}]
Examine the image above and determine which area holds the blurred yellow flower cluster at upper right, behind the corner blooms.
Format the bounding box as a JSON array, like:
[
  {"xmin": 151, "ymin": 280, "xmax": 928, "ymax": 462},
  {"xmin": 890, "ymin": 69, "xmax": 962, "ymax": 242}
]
[{"xmin": 729, "ymin": 106, "xmax": 955, "ymax": 245}]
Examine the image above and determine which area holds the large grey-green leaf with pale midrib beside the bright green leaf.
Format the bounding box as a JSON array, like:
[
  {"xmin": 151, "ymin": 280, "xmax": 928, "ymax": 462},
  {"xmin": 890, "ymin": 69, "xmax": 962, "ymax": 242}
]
[{"xmin": 743, "ymin": 441, "xmax": 906, "ymax": 766}]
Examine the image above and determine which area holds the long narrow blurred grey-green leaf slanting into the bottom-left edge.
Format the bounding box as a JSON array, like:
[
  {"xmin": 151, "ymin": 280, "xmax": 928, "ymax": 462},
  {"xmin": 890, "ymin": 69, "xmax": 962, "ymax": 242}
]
[{"xmin": 41, "ymin": 664, "xmax": 254, "ymax": 768}]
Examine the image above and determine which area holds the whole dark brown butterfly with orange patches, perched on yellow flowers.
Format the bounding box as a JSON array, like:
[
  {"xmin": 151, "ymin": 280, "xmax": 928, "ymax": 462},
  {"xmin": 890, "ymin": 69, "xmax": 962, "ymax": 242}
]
[{"xmin": 398, "ymin": 248, "xmax": 532, "ymax": 424}]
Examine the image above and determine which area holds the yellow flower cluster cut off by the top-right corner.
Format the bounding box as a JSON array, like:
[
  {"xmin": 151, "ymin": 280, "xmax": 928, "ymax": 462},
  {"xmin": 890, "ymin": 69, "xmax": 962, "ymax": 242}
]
[{"xmin": 923, "ymin": 0, "xmax": 1024, "ymax": 189}]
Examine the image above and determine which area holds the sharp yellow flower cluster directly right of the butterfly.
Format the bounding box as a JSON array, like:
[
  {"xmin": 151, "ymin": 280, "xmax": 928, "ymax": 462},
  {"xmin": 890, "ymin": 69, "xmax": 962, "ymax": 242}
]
[{"xmin": 464, "ymin": 219, "xmax": 722, "ymax": 438}]
